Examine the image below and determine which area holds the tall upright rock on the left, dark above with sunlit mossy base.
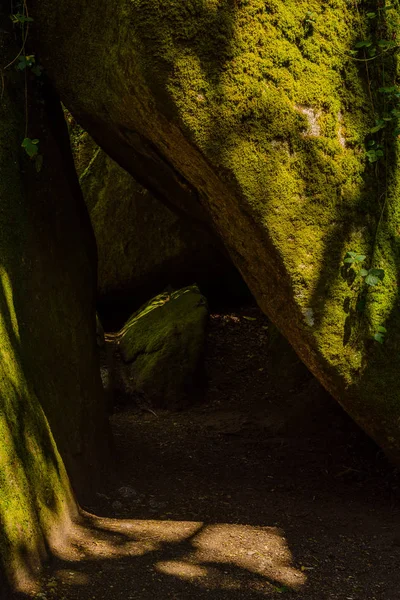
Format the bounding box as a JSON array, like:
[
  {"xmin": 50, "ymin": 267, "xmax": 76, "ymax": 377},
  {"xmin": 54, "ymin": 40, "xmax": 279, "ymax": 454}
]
[{"xmin": 0, "ymin": 7, "xmax": 107, "ymax": 598}]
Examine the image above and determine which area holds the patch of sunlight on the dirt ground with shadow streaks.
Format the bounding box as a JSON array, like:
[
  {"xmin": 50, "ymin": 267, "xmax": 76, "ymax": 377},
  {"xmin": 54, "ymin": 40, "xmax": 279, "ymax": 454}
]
[{"xmin": 52, "ymin": 514, "xmax": 306, "ymax": 594}]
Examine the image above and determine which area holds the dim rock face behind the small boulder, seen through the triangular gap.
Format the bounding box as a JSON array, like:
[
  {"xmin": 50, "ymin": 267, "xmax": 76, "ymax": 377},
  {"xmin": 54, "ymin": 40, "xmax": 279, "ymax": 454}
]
[{"xmin": 71, "ymin": 129, "xmax": 234, "ymax": 309}]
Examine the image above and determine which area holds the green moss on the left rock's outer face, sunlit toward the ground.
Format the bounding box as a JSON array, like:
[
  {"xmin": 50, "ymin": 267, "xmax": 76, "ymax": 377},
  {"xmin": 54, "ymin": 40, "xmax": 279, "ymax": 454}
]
[{"xmin": 0, "ymin": 75, "xmax": 76, "ymax": 589}]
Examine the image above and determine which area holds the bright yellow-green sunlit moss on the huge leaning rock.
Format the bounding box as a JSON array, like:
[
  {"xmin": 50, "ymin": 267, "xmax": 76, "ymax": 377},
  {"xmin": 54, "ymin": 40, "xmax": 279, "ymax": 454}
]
[{"xmin": 126, "ymin": 0, "xmax": 393, "ymax": 383}]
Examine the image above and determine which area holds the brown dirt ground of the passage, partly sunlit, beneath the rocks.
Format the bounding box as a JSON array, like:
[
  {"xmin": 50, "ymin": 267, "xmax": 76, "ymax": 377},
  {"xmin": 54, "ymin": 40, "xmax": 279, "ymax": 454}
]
[{"xmin": 14, "ymin": 306, "xmax": 400, "ymax": 600}]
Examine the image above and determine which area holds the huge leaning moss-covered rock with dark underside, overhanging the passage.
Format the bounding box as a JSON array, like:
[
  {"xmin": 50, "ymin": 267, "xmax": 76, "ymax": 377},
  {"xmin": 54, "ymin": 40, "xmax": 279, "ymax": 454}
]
[{"xmin": 33, "ymin": 0, "xmax": 400, "ymax": 461}]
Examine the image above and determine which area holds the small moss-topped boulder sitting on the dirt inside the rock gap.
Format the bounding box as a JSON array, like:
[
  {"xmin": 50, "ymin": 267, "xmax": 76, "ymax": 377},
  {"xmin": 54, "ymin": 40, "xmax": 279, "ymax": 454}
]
[{"xmin": 114, "ymin": 286, "xmax": 208, "ymax": 409}]
